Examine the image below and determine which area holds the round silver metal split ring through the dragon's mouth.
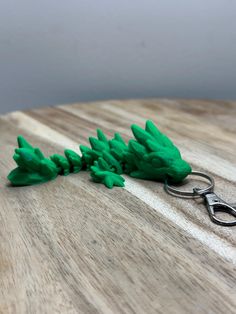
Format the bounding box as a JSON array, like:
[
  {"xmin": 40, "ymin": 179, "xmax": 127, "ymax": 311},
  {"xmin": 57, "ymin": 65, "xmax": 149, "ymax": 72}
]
[{"xmin": 164, "ymin": 171, "xmax": 215, "ymax": 198}]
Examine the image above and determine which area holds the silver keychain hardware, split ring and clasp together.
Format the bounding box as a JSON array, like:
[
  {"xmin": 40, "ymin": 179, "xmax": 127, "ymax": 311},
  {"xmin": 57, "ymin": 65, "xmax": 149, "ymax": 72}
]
[{"xmin": 164, "ymin": 171, "xmax": 236, "ymax": 226}]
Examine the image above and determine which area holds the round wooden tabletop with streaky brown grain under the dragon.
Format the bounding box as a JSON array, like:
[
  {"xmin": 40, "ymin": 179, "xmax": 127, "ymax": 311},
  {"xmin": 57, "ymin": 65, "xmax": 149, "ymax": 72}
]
[{"xmin": 0, "ymin": 99, "xmax": 236, "ymax": 314}]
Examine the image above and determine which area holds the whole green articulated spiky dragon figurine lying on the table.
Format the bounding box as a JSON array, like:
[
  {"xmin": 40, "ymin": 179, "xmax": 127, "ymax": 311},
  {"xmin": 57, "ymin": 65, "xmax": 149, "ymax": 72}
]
[{"xmin": 8, "ymin": 120, "xmax": 191, "ymax": 188}]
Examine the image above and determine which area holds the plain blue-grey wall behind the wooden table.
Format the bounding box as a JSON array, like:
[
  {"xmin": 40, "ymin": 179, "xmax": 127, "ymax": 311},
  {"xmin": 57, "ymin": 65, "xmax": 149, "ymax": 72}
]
[{"xmin": 0, "ymin": 0, "xmax": 236, "ymax": 112}]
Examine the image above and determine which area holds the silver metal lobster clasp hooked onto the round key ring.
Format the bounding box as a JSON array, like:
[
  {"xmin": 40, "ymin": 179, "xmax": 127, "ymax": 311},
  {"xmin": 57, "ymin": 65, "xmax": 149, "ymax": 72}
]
[{"xmin": 195, "ymin": 189, "xmax": 236, "ymax": 226}]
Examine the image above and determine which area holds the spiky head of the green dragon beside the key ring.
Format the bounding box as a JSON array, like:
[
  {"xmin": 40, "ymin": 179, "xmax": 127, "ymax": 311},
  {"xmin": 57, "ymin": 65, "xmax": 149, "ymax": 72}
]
[{"xmin": 129, "ymin": 120, "xmax": 191, "ymax": 183}]
